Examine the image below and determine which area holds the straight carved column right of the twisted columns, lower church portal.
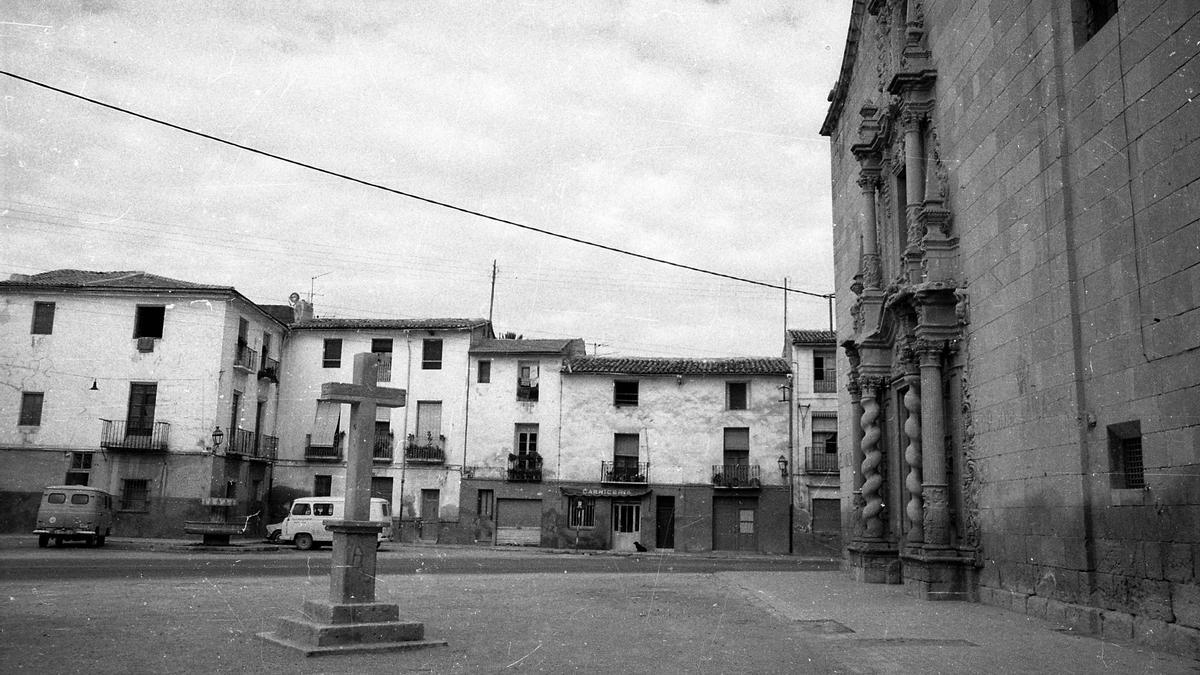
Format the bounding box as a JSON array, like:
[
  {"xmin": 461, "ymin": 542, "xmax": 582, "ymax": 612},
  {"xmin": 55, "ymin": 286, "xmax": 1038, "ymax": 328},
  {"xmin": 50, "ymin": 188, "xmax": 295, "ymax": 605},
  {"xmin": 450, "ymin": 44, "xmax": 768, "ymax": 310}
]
[{"xmin": 917, "ymin": 340, "xmax": 950, "ymax": 549}]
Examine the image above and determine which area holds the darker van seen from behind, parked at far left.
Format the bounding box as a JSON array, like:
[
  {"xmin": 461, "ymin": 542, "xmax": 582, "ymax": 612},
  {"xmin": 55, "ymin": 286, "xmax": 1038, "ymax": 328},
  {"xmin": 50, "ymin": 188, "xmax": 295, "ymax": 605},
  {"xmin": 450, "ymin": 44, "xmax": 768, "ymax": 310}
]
[{"xmin": 34, "ymin": 485, "xmax": 113, "ymax": 548}]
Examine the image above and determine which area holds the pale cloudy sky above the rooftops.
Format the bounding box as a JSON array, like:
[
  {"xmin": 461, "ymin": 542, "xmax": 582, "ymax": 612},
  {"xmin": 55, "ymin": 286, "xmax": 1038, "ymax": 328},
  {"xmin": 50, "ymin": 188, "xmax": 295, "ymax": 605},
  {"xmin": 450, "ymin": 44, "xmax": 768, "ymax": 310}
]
[{"xmin": 0, "ymin": 0, "xmax": 851, "ymax": 358}]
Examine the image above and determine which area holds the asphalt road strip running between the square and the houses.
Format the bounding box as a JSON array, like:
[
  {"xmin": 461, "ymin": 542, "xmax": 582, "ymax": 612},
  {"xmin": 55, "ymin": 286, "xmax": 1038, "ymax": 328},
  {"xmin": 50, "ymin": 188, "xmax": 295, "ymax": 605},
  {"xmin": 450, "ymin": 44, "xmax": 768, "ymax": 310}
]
[{"xmin": 0, "ymin": 546, "xmax": 838, "ymax": 581}]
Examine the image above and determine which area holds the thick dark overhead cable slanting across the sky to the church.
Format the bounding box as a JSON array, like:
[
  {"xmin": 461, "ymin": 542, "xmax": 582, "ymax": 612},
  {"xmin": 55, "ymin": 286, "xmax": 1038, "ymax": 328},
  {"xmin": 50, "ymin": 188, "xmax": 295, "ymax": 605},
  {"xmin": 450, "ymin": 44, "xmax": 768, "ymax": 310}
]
[{"xmin": 0, "ymin": 71, "xmax": 833, "ymax": 299}]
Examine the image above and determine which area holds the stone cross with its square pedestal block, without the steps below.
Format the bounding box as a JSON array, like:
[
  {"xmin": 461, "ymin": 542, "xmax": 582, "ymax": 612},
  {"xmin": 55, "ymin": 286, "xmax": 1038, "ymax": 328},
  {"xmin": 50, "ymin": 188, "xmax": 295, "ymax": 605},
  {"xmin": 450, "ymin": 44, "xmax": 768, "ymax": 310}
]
[{"xmin": 319, "ymin": 353, "xmax": 406, "ymax": 604}]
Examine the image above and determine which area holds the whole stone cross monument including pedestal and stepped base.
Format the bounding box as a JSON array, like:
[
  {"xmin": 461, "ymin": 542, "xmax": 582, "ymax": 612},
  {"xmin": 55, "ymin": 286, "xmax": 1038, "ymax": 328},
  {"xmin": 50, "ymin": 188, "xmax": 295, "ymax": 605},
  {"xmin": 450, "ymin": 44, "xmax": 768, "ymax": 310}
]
[{"xmin": 258, "ymin": 353, "xmax": 446, "ymax": 656}]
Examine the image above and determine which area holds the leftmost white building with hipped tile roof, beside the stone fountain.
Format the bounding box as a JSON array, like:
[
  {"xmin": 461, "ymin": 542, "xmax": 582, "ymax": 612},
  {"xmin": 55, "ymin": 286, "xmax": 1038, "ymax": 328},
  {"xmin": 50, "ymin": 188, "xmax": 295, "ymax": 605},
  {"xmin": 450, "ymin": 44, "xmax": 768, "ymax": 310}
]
[{"xmin": 0, "ymin": 269, "xmax": 289, "ymax": 536}]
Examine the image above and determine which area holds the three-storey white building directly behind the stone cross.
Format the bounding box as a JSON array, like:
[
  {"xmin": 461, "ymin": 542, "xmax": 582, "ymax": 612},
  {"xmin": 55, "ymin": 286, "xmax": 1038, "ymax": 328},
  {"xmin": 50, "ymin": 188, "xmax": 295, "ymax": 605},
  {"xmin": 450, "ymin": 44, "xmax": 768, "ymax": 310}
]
[{"xmin": 272, "ymin": 318, "xmax": 492, "ymax": 539}]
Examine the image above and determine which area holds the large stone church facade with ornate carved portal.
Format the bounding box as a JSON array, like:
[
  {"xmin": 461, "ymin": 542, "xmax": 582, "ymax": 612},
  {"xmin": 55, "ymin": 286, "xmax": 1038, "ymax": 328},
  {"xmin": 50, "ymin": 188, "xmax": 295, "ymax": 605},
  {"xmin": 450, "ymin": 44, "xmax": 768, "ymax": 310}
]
[{"xmin": 822, "ymin": 0, "xmax": 1200, "ymax": 653}]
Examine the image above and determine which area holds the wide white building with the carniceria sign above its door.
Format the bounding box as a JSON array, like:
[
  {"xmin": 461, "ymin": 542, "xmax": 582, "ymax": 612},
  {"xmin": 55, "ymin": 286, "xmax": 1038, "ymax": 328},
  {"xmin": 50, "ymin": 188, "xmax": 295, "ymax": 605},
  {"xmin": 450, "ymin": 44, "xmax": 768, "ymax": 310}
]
[{"xmin": 554, "ymin": 357, "xmax": 792, "ymax": 552}]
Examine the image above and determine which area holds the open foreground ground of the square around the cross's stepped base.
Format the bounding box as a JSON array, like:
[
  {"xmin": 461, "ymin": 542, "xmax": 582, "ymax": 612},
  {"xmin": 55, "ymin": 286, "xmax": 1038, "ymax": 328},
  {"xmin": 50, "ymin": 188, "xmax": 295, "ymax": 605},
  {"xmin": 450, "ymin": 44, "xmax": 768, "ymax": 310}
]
[{"xmin": 0, "ymin": 564, "xmax": 1200, "ymax": 673}]
